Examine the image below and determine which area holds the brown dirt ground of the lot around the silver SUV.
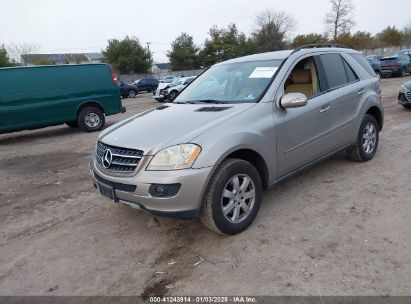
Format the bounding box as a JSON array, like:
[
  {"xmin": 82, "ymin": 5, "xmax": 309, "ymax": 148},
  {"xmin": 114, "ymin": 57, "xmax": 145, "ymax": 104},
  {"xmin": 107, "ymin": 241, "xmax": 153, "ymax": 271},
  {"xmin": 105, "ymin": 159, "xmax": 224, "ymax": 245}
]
[{"xmin": 0, "ymin": 76, "xmax": 411, "ymax": 295}]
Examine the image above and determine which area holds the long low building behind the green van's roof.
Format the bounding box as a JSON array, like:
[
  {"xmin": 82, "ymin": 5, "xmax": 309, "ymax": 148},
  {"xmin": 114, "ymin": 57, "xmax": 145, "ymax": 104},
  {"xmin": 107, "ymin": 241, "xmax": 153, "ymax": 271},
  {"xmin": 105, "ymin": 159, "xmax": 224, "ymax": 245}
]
[{"xmin": 21, "ymin": 53, "xmax": 103, "ymax": 65}]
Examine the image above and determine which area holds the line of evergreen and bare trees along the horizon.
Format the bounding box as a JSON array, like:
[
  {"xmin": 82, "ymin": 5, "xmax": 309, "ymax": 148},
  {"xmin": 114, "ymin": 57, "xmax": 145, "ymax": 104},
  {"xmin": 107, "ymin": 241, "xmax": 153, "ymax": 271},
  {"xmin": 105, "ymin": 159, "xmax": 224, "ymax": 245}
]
[{"xmin": 0, "ymin": 0, "xmax": 411, "ymax": 70}]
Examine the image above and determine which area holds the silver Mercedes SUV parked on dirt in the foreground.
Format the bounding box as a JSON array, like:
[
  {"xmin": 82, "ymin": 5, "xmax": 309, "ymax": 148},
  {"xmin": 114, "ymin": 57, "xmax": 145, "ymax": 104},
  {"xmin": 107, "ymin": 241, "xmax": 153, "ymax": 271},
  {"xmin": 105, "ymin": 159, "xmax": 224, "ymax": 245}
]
[{"xmin": 91, "ymin": 46, "xmax": 383, "ymax": 235}]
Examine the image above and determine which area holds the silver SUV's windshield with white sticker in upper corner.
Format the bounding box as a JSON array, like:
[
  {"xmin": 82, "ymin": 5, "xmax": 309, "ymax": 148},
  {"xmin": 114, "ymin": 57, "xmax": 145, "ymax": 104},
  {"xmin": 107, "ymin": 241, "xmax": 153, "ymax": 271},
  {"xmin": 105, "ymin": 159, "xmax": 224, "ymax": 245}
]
[{"xmin": 175, "ymin": 59, "xmax": 283, "ymax": 103}]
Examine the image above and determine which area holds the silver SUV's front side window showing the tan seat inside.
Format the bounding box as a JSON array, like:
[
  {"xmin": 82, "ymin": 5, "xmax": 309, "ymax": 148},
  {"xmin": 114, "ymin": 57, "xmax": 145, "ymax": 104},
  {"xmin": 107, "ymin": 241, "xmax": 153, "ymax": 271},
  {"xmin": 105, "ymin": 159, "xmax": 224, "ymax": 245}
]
[{"xmin": 284, "ymin": 57, "xmax": 321, "ymax": 98}]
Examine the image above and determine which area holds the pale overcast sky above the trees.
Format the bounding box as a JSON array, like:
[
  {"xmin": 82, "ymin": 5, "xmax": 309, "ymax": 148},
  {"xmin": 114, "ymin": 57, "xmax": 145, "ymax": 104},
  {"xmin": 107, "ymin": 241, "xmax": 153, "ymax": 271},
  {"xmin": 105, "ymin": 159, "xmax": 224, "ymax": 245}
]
[{"xmin": 0, "ymin": 0, "xmax": 411, "ymax": 62}]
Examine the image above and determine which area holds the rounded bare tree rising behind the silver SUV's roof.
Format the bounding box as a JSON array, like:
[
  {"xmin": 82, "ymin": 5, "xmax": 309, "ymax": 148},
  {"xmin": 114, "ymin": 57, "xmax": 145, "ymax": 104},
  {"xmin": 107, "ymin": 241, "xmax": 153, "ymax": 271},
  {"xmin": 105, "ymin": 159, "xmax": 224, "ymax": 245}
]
[{"xmin": 252, "ymin": 10, "xmax": 297, "ymax": 51}]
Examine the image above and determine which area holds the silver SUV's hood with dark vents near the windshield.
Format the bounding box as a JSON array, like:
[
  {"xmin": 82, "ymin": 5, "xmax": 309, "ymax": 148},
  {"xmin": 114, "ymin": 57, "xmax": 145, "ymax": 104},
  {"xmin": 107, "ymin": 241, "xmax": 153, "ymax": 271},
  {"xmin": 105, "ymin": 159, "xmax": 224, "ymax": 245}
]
[{"xmin": 99, "ymin": 103, "xmax": 256, "ymax": 155}]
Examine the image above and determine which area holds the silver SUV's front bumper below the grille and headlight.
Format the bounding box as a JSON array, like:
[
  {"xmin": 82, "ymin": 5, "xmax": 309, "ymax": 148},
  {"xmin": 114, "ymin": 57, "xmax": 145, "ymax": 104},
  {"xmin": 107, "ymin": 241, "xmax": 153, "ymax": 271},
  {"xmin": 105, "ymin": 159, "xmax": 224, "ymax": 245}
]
[{"xmin": 90, "ymin": 155, "xmax": 212, "ymax": 219}]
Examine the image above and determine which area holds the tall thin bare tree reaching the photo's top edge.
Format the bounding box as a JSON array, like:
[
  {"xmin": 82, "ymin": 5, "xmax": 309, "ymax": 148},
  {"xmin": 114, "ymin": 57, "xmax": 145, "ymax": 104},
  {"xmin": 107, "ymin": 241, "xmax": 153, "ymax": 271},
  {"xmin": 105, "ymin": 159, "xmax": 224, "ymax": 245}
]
[{"xmin": 325, "ymin": 0, "xmax": 355, "ymax": 40}]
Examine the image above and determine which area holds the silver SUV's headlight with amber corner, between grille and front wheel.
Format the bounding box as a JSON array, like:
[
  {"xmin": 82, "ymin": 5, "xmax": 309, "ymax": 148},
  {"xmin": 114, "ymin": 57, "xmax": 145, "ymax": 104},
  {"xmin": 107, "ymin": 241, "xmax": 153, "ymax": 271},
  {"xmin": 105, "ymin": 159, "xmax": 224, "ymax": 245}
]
[{"xmin": 146, "ymin": 144, "xmax": 201, "ymax": 171}]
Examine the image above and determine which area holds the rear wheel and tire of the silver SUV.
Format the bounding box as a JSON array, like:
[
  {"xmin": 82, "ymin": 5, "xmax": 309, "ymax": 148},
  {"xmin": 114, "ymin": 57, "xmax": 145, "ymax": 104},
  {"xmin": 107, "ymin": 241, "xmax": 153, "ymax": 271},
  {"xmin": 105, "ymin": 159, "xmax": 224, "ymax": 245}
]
[{"xmin": 347, "ymin": 114, "xmax": 379, "ymax": 162}]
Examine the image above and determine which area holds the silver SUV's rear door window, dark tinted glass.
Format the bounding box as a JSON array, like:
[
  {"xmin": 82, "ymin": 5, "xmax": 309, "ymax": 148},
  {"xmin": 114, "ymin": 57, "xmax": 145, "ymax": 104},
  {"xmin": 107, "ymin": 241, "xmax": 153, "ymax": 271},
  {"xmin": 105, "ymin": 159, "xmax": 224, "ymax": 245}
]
[{"xmin": 320, "ymin": 54, "xmax": 350, "ymax": 89}]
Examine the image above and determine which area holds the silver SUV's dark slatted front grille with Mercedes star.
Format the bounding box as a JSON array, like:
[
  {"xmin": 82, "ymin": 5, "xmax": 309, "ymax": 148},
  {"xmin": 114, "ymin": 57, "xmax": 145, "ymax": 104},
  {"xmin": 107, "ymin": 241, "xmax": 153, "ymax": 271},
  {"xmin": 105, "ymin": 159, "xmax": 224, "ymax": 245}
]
[{"xmin": 96, "ymin": 142, "xmax": 144, "ymax": 173}]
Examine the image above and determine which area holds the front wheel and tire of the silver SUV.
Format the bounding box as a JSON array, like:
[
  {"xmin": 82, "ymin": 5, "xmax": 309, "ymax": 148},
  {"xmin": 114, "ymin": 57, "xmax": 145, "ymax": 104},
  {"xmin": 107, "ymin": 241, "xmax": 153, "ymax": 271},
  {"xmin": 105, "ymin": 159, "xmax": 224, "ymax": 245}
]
[{"xmin": 200, "ymin": 159, "xmax": 262, "ymax": 235}]
